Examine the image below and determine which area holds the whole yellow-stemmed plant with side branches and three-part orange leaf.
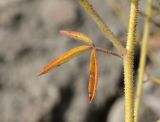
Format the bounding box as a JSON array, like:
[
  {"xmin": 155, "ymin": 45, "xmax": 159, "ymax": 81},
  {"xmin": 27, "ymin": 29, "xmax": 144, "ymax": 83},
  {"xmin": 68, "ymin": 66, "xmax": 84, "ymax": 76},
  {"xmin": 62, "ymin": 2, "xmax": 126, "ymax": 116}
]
[{"xmin": 38, "ymin": 0, "xmax": 160, "ymax": 122}]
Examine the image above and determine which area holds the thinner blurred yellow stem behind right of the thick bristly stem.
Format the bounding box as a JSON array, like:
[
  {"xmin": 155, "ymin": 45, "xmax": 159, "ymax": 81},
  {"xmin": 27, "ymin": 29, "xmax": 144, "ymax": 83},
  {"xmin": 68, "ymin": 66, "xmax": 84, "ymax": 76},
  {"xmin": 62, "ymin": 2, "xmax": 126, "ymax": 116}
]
[{"xmin": 134, "ymin": 0, "xmax": 152, "ymax": 122}]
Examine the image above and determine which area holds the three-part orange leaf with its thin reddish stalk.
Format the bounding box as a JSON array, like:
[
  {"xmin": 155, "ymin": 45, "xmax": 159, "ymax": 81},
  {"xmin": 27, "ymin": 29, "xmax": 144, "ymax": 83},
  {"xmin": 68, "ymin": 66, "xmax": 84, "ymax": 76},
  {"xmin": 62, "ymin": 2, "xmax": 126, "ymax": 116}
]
[{"xmin": 38, "ymin": 31, "xmax": 121, "ymax": 103}]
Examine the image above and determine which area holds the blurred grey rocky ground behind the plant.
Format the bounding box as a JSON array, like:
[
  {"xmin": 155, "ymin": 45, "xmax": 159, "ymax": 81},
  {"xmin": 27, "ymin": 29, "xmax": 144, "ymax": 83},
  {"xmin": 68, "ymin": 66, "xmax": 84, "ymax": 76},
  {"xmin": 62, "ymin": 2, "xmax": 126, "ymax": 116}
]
[{"xmin": 0, "ymin": 0, "xmax": 160, "ymax": 122}]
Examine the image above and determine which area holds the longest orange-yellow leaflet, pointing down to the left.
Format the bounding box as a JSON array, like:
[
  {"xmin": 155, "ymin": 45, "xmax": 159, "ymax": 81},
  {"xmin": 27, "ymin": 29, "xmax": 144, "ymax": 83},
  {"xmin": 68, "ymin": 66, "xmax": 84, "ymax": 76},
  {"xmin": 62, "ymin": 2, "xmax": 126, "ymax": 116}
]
[{"xmin": 38, "ymin": 45, "xmax": 91, "ymax": 76}]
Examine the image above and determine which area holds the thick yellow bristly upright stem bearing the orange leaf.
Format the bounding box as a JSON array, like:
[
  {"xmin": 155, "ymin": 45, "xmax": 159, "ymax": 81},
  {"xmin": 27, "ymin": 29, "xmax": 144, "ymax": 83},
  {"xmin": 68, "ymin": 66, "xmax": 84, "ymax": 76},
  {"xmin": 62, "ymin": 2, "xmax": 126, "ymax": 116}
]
[{"xmin": 123, "ymin": 0, "xmax": 138, "ymax": 122}]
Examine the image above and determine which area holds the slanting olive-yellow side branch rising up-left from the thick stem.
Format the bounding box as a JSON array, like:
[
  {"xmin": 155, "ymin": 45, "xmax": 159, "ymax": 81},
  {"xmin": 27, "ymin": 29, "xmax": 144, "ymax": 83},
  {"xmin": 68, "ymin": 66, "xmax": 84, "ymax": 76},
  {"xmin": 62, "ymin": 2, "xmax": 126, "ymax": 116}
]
[{"xmin": 80, "ymin": 0, "xmax": 126, "ymax": 54}]
